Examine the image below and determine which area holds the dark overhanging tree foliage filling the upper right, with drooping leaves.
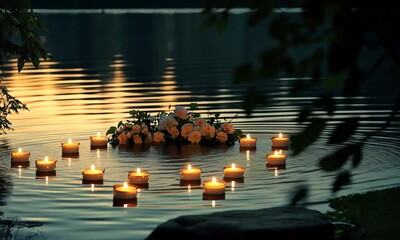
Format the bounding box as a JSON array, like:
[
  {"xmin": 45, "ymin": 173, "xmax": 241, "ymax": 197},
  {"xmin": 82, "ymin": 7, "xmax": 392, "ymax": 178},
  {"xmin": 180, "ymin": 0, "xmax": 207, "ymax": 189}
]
[{"xmin": 201, "ymin": 0, "xmax": 400, "ymax": 204}]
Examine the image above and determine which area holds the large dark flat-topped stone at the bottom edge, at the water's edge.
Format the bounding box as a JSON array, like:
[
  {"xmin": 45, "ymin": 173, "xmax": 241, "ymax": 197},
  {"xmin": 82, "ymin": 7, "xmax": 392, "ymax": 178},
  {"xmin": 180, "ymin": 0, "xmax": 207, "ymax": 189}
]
[{"xmin": 146, "ymin": 207, "xmax": 334, "ymax": 240}]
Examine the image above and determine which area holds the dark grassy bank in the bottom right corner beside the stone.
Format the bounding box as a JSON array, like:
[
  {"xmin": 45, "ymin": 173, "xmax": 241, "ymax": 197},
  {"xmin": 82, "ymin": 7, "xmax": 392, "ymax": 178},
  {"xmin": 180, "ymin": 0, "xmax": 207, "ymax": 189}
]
[{"xmin": 326, "ymin": 186, "xmax": 400, "ymax": 240}]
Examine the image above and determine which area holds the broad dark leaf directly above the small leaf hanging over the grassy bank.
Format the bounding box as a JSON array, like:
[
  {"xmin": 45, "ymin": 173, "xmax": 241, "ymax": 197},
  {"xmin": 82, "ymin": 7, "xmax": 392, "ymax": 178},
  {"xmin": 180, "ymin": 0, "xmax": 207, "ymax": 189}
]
[{"xmin": 319, "ymin": 145, "xmax": 355, "ymax": 172}]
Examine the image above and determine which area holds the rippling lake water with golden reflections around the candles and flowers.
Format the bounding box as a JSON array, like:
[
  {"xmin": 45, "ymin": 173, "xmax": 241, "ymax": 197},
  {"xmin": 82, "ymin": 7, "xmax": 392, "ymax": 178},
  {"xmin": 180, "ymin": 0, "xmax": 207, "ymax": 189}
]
[{"xmin": 0, "ymin": 10, "xmax": 400, "ymax": 239}]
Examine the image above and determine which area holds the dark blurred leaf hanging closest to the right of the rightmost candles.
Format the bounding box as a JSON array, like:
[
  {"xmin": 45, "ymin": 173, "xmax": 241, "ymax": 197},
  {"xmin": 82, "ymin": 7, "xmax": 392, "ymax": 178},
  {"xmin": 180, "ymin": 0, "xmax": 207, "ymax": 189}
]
[{"xmin": 291, "ymin": 118, "xmax": 325, "ymax": 155}]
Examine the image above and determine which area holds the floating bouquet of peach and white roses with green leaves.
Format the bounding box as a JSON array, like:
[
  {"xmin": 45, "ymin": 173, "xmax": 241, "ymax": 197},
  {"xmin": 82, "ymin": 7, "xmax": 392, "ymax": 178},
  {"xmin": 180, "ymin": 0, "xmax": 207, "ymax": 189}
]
[{"xmin": 106, "ymin": 103, "xmax": 243, "ymax": 146}]
